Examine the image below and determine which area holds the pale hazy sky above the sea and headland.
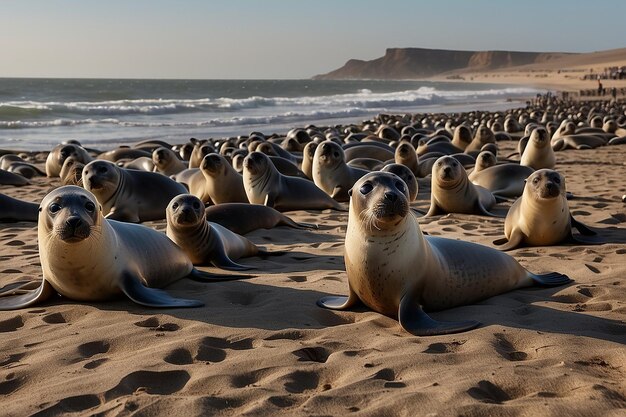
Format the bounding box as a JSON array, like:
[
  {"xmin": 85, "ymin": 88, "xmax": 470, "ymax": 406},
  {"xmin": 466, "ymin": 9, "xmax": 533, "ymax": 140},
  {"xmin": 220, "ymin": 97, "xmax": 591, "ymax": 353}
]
[{"xmin": 0, "ymin": 0, "xmax": 626, "ymax": 79}]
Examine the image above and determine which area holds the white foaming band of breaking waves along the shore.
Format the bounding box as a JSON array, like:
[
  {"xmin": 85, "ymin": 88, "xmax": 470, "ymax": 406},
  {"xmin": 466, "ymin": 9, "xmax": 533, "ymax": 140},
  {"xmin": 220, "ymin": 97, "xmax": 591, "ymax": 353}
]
[{"xmin": 0, "ymin": 87, "xmax": 538, "ymax": 118}]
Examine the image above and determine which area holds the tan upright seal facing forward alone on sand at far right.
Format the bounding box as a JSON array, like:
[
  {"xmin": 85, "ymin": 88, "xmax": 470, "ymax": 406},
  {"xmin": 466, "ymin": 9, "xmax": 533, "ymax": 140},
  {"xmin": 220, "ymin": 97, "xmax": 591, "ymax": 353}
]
[{"xmin": 494, "ymin": 169, "xmax": 599, "ymax": 251}]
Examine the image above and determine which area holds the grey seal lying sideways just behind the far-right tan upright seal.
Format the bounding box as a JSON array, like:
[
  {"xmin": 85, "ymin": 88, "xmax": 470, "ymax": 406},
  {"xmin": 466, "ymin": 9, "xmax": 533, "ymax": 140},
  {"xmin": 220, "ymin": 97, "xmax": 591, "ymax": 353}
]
[{"xmin": 468, "ymin": 151, "xmax": 534, "ymax": 197}]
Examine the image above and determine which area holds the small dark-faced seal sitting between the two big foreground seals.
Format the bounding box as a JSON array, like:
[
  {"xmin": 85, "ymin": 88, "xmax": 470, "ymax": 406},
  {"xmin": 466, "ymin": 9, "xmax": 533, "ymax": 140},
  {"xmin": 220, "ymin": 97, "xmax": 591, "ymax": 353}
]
[{"xmin": 166, "ymin": 194, "xmax": 268, "ymax": 270}]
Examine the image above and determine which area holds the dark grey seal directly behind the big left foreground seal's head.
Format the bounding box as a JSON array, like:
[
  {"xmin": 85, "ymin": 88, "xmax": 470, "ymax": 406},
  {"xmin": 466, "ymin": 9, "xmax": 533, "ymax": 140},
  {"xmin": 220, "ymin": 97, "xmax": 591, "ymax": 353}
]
[{"xmin": 83, "ymin": 160, "xmax": 187, "ymax": 223}]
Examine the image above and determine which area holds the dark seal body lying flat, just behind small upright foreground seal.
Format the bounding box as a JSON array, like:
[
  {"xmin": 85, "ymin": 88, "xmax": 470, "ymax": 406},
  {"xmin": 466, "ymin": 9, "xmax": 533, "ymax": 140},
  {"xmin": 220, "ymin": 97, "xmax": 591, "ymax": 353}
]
[{"xmin": 204, "ymin": 203, "xmax": 317, "ymax": 235}]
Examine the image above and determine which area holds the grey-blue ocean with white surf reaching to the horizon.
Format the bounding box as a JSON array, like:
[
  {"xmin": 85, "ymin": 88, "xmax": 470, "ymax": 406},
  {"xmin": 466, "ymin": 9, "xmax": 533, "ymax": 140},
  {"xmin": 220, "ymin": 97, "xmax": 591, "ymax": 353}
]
[{"xmin": 0, "ymin": 78, "xmax": 543, "ymax": 150}]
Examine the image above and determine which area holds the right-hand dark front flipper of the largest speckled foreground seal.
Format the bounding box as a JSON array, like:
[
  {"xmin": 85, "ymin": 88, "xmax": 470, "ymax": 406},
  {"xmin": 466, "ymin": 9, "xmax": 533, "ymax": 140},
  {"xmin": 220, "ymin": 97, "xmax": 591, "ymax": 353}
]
[{"xmin": 398, "ymin": 294, "xmax": 480, "ymax": 336}]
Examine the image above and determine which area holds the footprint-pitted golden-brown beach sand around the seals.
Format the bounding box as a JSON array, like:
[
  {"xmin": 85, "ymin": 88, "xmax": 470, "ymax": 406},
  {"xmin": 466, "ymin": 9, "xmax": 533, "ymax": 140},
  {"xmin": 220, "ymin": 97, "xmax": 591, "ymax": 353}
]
[{"xmin": 0, "ymin": 135, "xmax": 626, "ymax": 416}]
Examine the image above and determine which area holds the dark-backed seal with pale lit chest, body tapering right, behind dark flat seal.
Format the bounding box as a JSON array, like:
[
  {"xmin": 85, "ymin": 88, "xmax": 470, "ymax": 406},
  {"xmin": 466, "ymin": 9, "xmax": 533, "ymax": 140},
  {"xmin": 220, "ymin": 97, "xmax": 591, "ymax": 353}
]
[{"xmin": 243, "ymin": 152, "xmax": 343, "ymax": 211}]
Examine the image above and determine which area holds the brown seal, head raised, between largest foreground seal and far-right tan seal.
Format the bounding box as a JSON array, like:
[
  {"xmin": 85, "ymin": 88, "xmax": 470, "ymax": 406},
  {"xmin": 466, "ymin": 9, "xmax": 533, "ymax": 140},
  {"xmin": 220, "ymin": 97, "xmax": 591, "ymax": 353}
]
[{"xmin": 426, "ymin": 156, "xmax": 498, "ymax": 217}]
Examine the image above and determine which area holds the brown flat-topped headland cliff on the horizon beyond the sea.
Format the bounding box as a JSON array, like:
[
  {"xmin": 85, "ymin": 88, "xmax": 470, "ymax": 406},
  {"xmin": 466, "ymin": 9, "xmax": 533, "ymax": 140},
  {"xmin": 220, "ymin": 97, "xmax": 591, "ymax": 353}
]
[{"xmin": 313, "ymin": 48, "xmax": 570, "ymax": 80}]
